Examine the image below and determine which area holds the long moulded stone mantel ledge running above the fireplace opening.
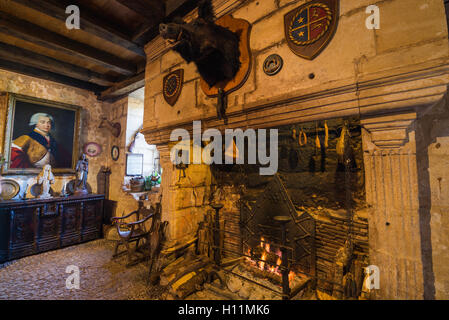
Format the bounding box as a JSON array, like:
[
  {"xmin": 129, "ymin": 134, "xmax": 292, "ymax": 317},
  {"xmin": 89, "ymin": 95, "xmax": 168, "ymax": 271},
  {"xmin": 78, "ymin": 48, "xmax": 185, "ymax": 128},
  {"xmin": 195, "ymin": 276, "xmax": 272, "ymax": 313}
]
[{"xmin": 142, "ymin": 59, "xmax": 449, "ymax": 146}]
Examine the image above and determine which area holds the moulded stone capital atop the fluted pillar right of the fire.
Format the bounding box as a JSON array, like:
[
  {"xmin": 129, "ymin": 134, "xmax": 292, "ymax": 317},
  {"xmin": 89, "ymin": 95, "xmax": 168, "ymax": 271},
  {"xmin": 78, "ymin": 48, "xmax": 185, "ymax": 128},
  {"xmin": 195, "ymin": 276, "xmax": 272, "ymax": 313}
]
[{"xmin": 361, "ymin": 112, "xmax": 416, "ymax": 149}]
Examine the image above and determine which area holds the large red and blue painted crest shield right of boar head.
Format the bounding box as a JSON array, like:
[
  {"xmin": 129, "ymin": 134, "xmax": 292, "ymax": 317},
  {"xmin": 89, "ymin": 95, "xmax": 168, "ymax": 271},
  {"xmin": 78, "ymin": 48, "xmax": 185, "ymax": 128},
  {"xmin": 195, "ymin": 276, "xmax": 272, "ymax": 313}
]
[{"xmin": 284, "ymin": 0, "xmax": 340, "ymax": 60}]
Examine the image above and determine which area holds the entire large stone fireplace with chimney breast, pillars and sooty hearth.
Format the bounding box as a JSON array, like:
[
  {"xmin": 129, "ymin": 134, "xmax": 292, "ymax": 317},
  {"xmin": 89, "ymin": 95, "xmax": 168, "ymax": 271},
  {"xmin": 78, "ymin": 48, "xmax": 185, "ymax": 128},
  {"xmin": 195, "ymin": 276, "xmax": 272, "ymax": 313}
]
[{"xmin": 142, "ymin": 0, "xmax": 449, "ymax": 299}]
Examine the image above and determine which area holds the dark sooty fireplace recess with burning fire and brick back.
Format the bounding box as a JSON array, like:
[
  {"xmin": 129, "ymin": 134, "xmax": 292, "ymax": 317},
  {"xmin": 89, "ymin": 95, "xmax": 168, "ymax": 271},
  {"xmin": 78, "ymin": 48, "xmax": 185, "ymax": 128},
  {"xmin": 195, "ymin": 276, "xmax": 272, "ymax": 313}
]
[{"xmin": 205, "ymin": 118, "xmax": 369, "ymax": 297}]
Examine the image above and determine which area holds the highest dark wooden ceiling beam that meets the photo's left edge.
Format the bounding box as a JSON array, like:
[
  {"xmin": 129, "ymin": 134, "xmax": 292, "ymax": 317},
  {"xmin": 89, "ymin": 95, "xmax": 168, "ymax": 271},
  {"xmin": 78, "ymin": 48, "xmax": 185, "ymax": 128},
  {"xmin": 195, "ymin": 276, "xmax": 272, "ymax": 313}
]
[{"xmin": 0, "ymin": 12, "xmax": 137, "ymax": 75}]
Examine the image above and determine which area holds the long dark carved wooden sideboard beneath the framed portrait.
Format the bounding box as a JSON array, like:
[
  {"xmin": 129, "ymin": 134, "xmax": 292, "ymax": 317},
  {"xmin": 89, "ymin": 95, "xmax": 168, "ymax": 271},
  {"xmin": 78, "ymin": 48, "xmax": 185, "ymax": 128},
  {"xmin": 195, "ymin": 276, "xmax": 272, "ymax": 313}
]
[{"xmin": 0, "ymin": 194, "xmax": 104, "ymax": 263}]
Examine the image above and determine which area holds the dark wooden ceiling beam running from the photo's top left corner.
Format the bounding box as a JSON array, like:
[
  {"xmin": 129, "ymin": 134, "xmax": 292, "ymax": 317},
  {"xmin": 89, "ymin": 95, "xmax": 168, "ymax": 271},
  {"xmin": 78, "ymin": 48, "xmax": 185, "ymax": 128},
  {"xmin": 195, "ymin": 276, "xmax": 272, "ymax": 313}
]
[{"xmin": 10, "ymin": 0, "xmax": 145, "ymax": 57}]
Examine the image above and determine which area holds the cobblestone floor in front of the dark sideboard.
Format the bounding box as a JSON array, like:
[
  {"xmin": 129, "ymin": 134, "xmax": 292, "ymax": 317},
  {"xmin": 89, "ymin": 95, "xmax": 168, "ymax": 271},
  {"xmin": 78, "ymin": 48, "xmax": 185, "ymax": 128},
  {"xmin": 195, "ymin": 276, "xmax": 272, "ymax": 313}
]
[{"xmin": 0, "ymin": 240, "xmax": 160, "ymax": 300}]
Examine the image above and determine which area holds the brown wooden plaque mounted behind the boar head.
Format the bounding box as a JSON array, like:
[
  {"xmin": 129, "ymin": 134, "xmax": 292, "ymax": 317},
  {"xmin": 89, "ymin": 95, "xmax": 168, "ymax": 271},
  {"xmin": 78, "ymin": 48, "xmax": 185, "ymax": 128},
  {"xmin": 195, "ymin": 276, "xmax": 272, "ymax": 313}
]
[{"xmin": 201, "ymin": 15, "xmax": 251, "ymax": 97}]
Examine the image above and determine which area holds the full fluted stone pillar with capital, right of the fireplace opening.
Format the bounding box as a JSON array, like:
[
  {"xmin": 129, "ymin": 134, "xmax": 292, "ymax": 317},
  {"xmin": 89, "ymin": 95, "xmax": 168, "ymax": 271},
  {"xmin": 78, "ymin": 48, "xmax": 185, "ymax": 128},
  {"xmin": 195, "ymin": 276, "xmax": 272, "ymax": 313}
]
[{"xmin": 361, "ymin": 112, "xmax": 424, "ymax": 299}]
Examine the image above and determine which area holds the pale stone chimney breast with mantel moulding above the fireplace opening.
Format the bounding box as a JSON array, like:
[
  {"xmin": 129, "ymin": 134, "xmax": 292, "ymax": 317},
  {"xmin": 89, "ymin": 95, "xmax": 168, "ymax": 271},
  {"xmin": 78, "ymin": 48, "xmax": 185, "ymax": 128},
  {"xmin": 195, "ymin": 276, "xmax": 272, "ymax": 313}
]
[{"xmin": 144, "ymin": 0, "xmax": 448, "ymax": 138}]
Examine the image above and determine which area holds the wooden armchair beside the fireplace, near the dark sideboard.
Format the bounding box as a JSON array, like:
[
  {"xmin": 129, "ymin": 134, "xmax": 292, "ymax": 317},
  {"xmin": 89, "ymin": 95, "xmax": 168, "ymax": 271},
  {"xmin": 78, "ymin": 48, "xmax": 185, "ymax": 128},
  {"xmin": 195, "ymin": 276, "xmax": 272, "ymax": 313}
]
[{"xmin": 111, "ymin": 201, "xmax": 158, "ymax": 267}]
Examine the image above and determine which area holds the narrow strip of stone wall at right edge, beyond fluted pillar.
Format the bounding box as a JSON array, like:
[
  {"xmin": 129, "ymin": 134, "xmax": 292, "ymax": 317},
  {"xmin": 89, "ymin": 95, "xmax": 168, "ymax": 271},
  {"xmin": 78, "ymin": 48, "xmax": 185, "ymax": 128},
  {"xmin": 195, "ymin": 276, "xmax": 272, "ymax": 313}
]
[{"xmin": 417, "ymin": 98, "xmax": 449, "ymax": 300}]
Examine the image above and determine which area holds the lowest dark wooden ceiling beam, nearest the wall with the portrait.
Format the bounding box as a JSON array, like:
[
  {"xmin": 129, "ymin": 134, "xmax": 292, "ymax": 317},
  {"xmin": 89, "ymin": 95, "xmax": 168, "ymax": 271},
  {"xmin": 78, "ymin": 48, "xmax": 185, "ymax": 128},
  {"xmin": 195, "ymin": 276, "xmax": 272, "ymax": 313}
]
[{"xmin": 0, "ymin": 58, "xmax": 106, "ymax": 93}]
